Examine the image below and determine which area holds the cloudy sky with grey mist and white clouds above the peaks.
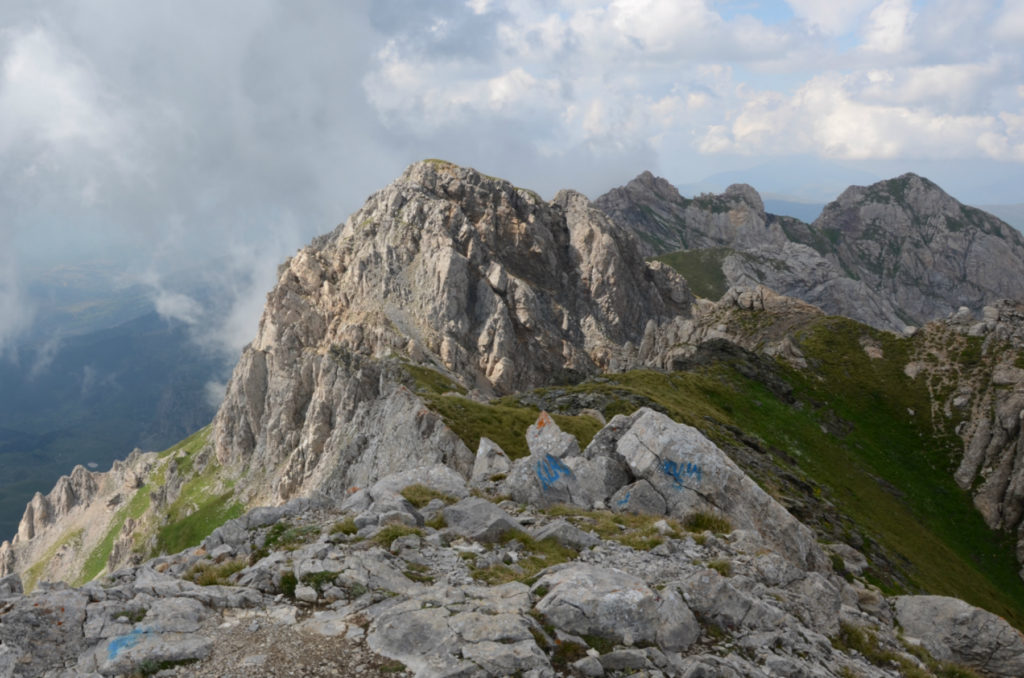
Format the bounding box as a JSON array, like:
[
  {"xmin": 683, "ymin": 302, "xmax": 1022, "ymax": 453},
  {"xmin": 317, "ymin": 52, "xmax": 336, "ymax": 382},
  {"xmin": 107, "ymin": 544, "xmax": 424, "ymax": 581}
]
[{"xmin": 0, "ymin": 0, "xmax": 1024, "ymax": 366}]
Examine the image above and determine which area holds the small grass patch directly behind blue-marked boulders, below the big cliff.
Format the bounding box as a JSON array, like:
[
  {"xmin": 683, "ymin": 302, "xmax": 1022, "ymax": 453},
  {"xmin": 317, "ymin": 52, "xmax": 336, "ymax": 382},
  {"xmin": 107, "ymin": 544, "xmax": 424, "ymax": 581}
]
[{"xmin": 424, "ymin": 394, "xmax": 601, "ymax": 459}]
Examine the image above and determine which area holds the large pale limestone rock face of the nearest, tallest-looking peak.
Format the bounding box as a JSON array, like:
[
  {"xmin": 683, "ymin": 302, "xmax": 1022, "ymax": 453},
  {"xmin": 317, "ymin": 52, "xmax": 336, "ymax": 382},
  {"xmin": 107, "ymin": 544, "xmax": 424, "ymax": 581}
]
[{"xmin": 213, "ymin": 162, "xmax": 691, "ymax": 501}]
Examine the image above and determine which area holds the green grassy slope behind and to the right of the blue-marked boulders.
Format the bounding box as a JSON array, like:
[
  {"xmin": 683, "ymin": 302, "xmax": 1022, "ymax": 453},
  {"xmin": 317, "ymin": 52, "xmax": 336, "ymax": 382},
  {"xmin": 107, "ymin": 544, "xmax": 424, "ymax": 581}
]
[{"xmin": 417, "ymin": 319, "xmax": 1024, "ymax": 627}]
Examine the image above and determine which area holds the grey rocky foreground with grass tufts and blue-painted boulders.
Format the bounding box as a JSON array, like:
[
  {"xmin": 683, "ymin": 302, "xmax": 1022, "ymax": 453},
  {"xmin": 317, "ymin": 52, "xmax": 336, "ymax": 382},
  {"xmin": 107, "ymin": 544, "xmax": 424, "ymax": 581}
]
[{"xmin": 0, "ymin": 409, "xmax": 1024, "ymax": 678}]
